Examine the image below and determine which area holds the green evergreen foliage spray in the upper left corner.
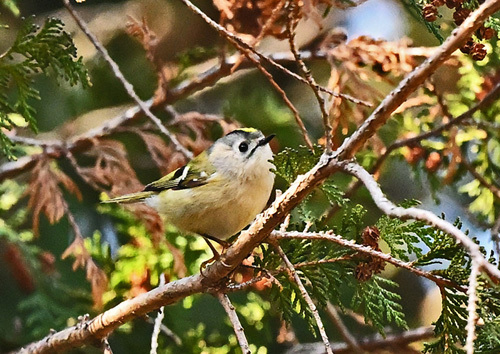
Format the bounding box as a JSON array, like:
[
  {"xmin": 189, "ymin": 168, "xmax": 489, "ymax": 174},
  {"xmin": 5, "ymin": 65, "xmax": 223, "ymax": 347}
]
[{"xmin": 0, "ymin": 18, "xmax": 90, "ymax": 159}]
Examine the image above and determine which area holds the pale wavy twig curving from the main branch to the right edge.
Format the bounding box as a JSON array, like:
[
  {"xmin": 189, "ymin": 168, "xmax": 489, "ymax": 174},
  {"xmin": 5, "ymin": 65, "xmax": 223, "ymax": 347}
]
[{"xmin": 336, "ymin": 161, "xmax": 500, "ymax": 280}]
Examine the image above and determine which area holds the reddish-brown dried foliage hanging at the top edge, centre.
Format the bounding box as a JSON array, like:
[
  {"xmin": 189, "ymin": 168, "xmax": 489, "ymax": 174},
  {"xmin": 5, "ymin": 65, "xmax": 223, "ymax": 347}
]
[{"xmin": 213, "ymin": 0, "xmax": 334, "ymax": 39}]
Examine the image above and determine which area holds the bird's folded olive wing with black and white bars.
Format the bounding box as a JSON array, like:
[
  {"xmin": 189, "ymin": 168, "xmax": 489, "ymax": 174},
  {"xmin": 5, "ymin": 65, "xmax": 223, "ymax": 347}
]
[{"xmin": 144, "ymin": 152, "xmax": 215, "ymax": 192}]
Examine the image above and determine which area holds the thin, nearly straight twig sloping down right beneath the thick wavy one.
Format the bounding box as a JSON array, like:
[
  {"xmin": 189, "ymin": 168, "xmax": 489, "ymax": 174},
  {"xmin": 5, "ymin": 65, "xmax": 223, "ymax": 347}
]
[{"xmin": 269, "ymin": 231, "xmax": 467, "ymax": 293}]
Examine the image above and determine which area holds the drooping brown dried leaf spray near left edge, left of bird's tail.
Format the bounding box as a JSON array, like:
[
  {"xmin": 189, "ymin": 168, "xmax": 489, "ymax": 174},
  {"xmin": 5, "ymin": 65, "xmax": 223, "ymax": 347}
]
[{"xmin": 26, "ymin": 157, "xmax": 82, "ymax": 235}]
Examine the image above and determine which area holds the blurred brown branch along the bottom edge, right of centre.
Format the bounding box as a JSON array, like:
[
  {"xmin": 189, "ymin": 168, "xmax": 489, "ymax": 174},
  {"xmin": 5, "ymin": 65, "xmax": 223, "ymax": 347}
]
[{"xmin": 286, "ymin": 327, "xmax": 434, "ymax": 354}]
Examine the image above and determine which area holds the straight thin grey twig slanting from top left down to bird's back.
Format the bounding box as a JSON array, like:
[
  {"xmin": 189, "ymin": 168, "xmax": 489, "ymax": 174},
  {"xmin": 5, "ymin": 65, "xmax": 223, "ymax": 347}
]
[{"xmin": 63, "ymin": 0, "xmax": 193, "ymax": 159}]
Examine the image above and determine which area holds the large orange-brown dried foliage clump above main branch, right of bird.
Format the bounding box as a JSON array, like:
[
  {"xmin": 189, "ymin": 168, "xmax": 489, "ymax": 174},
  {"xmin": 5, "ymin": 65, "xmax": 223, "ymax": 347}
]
[{"xmin": 320, "ymin": 37, "xmax": 418, "ymax": 151}]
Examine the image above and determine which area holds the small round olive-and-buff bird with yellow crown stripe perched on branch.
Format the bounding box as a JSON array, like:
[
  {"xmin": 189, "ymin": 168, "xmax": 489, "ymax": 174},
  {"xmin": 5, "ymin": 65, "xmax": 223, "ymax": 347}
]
[{"xmin": 104, "ymin": 128, "xmax": 274, "ymax": 262}]
